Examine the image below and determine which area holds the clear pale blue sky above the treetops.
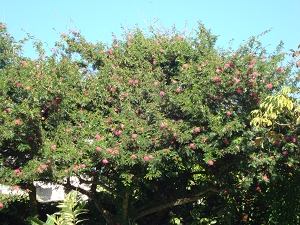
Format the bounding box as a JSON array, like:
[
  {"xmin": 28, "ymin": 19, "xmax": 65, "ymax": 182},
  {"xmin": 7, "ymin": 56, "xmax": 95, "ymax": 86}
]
[{"xmin": 0, "ymin": 0, "xmax": 300, "ymax": 57}]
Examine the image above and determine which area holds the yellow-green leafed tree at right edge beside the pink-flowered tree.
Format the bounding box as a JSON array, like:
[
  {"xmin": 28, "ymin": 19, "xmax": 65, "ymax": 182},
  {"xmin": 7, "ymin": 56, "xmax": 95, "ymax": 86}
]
[{"xmin": 251, "ymin": 84, "xmax": 300, "ymax": 224}]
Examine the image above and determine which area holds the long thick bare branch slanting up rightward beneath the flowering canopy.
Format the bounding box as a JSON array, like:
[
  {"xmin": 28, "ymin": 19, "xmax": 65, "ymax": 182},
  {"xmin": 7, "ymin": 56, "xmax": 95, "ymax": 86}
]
[{"xmin": 132, "ymin": 188, "xmax": 220, "ymax": 221}]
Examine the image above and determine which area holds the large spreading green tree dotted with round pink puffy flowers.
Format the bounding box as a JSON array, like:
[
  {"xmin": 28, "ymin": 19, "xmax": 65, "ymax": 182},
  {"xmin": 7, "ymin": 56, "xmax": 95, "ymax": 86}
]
[{"xmin": 0, "ymin": 21, "xmax": 298, "ymax": 224}]
